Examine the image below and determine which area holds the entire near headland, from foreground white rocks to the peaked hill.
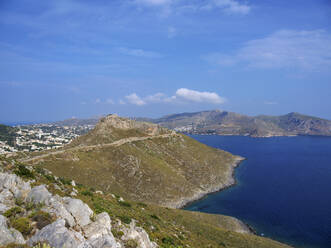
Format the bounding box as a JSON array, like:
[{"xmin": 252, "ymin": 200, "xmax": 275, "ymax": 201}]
[{"xmin": 0, "ymin": 115, "xmax": 289, "ymax": 248}]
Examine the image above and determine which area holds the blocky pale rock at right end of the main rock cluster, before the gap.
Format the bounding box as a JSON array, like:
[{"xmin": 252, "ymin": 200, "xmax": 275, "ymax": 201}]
[{"xmin": 83, "ymin": 212, "xmax": 112, "ymax": 239}]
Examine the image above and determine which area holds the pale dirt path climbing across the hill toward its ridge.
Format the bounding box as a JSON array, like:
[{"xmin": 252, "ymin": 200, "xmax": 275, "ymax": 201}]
[{"xmin": 20, "ymin": 133, "xmax": 178, "ymax": 162}]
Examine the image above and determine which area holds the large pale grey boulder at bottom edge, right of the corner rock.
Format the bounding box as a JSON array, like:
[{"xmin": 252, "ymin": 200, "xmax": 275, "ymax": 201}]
[{"xmin": 28, "ymin": 219, "xmax": 85, "ymax": 248}]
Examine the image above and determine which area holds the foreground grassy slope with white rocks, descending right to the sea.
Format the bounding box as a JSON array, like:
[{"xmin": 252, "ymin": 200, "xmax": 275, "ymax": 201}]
[{"xmin": 0, "ymin": 157, "xmax": 288, "ymax": 248}]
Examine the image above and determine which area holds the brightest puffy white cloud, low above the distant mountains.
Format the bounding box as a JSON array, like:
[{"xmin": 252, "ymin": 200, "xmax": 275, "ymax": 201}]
[{"xmin": 176, "ymin": 88, "xmax": 225, "ymax": 104}]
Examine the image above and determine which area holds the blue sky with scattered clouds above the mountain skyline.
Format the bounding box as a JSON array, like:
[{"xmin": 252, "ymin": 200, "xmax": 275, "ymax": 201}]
[{"xmin": 0, "ymin": 0, "xmax": 331, "ymax": 123}]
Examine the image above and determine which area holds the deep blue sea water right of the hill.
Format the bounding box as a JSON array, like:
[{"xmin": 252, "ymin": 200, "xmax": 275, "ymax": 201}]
[{"xmin": 186, "ymin": 135, "xmax": 331, "ymax": 248}]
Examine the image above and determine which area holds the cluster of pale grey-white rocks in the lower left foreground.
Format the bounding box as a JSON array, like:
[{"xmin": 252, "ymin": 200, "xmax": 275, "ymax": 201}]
[{"xmin": 0, "ymin": 173, "xmax": 157, "ymax": 248}]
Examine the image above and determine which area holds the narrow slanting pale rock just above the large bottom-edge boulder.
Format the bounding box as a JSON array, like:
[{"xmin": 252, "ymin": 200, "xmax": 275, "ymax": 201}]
[{"xmin": 43, "ymin": 195, "xmax": 76, "ymax": 227}]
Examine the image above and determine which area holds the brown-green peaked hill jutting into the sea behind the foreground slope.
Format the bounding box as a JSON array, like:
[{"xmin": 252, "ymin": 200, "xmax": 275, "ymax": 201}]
[{"xmin": 21, "ymin": 115, "xmax": 243, "ymax": 208}]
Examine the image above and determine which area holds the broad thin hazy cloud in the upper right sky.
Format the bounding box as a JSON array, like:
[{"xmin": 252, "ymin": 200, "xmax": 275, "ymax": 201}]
[{"xmin": 204, "ymin": 30, "xmax": 331, "ymax": 70}]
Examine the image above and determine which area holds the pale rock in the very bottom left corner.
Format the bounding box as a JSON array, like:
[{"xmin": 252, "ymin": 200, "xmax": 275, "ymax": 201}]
[{"xmin": 0, "ymin": 215, "xmax": 25, "ymax": 246}]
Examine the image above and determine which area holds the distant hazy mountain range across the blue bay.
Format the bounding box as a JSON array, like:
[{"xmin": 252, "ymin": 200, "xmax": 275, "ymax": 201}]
[{"xmin": 148, "ymin": 110, "xmax": 331, "ymax": 137}]
